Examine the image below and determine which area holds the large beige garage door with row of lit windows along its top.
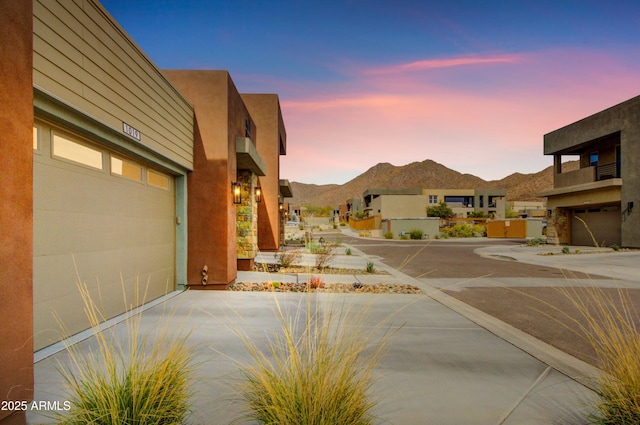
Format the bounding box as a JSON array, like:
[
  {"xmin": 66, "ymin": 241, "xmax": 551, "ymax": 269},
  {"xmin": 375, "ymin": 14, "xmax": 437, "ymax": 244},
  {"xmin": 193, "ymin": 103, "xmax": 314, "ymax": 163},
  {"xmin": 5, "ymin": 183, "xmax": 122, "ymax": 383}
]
[{"xmin": 33, "ymin": 123, "xmax": 175, "ymax": 350}]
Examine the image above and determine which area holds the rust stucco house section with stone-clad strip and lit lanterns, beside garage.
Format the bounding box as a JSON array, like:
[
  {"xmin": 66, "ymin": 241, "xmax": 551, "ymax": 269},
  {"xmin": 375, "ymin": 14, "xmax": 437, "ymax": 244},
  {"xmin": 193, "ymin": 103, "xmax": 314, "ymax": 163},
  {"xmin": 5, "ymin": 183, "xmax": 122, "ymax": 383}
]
[{"xmin": 164, "ymin": 70, "xmax": 268, "ymax": 274}]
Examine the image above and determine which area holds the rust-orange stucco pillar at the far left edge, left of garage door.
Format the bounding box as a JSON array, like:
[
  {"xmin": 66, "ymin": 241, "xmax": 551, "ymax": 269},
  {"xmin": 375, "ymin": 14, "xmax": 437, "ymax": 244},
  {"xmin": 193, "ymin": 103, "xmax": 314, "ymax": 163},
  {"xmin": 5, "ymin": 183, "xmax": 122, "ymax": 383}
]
[{"xmin": 0, "ymin": 0, "xmax": 33, "ymax": 425}]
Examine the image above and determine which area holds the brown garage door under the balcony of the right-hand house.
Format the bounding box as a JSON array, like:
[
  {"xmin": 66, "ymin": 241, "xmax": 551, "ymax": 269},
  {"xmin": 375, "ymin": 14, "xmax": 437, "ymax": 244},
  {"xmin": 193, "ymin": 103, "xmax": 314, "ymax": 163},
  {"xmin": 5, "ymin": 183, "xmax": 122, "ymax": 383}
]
[{"xmin": 571, "ymin": 205, "xmax": 622, "ymax": 246}]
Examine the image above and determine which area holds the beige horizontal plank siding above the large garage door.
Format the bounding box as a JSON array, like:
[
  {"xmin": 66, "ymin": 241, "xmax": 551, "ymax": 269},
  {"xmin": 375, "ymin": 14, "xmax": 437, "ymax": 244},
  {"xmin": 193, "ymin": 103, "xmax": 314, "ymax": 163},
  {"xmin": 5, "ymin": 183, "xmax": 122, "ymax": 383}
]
[{"xmin": 33, "ymin": 0, "xmax": 193, "ymax": 170}]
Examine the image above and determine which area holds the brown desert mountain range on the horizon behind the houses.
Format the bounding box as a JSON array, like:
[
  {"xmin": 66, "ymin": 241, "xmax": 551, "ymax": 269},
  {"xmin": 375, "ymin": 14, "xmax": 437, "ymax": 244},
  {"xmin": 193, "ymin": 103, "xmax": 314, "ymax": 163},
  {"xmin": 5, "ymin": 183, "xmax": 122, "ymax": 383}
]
[{"xmin": 288, "ymin": 159, "xmax": 578, "ymax": 207}]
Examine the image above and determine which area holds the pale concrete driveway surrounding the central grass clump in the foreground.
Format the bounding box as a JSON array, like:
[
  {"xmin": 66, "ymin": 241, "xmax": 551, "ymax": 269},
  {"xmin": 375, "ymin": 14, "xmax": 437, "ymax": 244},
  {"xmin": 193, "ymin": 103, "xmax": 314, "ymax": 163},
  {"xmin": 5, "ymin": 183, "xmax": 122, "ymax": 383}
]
[{"xmin": 28, "ymin": 230, "xmax": 608, "ymax": 425}]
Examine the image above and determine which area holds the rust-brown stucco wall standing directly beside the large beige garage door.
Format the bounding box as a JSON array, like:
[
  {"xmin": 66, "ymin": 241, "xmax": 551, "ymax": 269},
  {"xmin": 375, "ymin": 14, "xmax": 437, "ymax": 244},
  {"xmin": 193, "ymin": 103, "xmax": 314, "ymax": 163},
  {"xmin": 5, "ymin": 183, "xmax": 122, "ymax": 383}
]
[{"xmin": 164, "ymin": 70, "xmax": 256, "ymax": 289}]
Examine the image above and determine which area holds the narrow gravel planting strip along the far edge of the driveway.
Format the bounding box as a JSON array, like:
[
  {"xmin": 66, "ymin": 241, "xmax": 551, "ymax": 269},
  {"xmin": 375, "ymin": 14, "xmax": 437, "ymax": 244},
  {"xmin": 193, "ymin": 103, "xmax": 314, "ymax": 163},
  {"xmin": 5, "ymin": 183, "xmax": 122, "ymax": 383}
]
[{"xmin": 229, "ymin": 282, "xmax": 423, "ymax": 294}]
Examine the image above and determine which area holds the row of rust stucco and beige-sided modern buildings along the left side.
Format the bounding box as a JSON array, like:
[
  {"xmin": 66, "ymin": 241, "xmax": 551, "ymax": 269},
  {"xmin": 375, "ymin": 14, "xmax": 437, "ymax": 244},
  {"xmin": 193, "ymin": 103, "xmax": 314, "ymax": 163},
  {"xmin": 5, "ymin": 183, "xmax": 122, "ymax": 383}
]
[{"xmin": 0, "ymin": 0, "xmax": 291, "ymax": 424}]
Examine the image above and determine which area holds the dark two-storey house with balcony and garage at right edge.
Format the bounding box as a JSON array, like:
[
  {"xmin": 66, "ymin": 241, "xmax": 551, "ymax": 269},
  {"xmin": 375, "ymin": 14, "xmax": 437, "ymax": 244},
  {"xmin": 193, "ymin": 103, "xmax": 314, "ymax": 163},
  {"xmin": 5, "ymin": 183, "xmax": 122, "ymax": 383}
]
[{"xmin": 538, "ymin": 96, "xmax": 640, "ymax": 248}]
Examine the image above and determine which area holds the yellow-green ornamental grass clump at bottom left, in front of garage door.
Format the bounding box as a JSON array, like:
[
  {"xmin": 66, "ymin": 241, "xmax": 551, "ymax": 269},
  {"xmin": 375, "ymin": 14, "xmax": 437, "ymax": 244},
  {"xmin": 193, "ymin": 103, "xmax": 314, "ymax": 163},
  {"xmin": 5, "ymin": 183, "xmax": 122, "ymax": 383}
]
[{"xmin": 55, "ymin": 276, "xmax": 193, "ymax": 425}]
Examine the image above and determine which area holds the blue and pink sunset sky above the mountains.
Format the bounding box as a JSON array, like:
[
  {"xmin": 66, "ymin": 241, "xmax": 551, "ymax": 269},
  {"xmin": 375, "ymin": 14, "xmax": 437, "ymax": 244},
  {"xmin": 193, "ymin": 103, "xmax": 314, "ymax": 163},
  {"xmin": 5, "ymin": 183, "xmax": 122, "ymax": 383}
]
[{"xmin": 102, "ymin": 0, "xmax": 640, "ymax": 184}]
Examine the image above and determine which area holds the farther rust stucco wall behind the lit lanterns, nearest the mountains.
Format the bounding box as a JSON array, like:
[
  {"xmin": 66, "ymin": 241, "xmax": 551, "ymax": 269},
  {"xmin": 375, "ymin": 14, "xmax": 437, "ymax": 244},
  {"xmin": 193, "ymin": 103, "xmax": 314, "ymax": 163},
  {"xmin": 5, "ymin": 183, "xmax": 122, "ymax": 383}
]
[{"xmin": 241, "ymin": 94, "xmax": 287, "ymax": 251}]
